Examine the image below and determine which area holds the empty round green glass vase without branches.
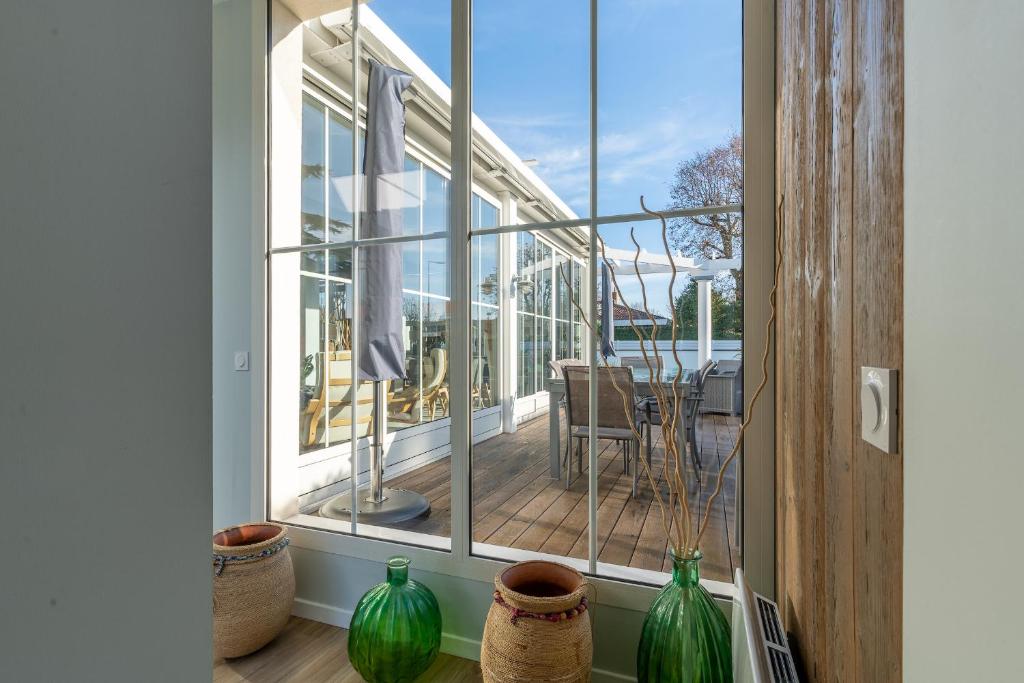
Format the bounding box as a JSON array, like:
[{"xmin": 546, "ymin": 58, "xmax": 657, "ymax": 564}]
[{"xmin": 348, "ymin": 557, "xmax": 441, "ymax": 683}]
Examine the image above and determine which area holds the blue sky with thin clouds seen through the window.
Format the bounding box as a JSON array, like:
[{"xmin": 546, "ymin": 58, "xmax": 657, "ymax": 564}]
[{"xmin": 369, "ymin": 0, "xmax": 742, "ymax": 313}]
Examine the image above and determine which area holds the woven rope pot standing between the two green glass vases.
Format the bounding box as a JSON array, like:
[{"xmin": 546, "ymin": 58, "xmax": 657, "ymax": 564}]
[{"xmin": 480, "ymin": 561, "xmax": 594, "ymax": 683}]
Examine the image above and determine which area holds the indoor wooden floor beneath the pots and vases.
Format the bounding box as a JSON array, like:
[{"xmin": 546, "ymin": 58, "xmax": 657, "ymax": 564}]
[{"xmin": 213, "ymin": 616, "xmax": 483, "ymax": 683}]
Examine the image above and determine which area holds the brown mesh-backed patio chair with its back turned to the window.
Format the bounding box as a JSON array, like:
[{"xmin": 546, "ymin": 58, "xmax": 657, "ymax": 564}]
[{"xmin": 562, "ymin": 366, "xmax": 640, "ymax": 497}]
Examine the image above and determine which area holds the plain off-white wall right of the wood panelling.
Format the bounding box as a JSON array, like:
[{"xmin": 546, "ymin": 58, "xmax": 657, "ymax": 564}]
[{"xmin": 903, "ymin": 0, "xmax": 1024, "ymax": 681}]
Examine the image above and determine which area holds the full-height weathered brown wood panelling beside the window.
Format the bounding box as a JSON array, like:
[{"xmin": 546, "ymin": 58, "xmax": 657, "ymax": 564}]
[{"xmin": 776, "ymin": 0, "xmax": 902, "ymax": 681}]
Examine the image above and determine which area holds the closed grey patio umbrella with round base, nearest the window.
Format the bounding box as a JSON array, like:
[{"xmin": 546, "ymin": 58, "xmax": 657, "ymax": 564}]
[{"xmin": 321, "ymin": 60, "xmax": 430, "ymax": 523}]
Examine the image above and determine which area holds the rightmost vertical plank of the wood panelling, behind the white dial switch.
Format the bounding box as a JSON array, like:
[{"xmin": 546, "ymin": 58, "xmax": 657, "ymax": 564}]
[{"xmin": 853, "ymin": 0, "xmax": 903, "ymax": 681}]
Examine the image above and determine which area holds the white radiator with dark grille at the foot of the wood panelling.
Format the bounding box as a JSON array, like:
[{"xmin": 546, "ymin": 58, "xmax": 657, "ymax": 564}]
[{"xmin": 732, "ymin": 569, "xmax": 800, "ymax": 683}]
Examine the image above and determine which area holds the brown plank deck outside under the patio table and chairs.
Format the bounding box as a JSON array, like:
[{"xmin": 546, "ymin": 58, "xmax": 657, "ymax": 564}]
[{"xmin": 380, "ymin": 415, "xmax": 740, "ymax": 582}]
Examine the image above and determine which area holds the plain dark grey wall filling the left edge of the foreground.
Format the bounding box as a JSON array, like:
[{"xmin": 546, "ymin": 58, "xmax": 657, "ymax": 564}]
[{"xmin": 0, "ymin": 0, "xmax": 212, "ymax": 682}]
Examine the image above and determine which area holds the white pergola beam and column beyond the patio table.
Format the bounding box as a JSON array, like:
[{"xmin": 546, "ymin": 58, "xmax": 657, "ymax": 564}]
[{"xmin": 604, "ymin": 247, "xmax": 742, "ymax": 368}]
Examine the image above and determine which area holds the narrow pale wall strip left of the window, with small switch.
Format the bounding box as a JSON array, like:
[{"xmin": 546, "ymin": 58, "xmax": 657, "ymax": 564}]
[{"xmin": 213, "ymin": 0, "xmax": 266, "ymax": 529}]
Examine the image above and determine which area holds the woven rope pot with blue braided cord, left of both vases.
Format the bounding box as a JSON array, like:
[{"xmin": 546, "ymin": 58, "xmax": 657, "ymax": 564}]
[{"xmin": 213, "ymin": 523, "xmax": 295, "ymax": 658}]
